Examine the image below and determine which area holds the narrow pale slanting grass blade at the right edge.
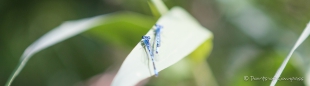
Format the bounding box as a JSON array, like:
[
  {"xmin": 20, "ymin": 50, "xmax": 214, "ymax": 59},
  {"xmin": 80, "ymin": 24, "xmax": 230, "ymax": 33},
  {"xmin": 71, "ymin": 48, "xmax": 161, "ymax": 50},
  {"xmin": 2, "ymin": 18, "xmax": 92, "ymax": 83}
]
[{"xmin": 270, "ymin": 22, "xmax": 310, "ymax": 86}]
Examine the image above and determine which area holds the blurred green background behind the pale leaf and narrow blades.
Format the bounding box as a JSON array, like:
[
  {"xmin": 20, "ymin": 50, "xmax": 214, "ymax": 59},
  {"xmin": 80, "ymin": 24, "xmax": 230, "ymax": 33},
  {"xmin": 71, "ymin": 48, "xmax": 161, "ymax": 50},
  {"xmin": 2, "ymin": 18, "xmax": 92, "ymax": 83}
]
[{"xmin": 0, "ymin": 0, "xmax": 310, "ymax": 86}]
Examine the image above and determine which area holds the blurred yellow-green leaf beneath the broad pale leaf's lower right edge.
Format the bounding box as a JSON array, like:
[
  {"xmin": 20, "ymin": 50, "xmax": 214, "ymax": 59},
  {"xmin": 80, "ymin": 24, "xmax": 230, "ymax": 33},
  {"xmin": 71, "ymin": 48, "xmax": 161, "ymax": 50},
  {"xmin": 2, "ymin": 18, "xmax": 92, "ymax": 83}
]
[{"xmin": 146, "ymin": 34, "xmax": 218, "ymax": 86}]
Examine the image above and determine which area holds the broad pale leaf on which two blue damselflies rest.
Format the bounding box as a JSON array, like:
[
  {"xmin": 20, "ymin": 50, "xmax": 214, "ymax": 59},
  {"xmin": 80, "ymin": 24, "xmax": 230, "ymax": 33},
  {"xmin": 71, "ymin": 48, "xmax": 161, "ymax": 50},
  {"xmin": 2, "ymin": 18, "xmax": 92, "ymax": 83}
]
[{"xmin": 112, "ymin": 7, "xmax": 212, "ymax": 86}]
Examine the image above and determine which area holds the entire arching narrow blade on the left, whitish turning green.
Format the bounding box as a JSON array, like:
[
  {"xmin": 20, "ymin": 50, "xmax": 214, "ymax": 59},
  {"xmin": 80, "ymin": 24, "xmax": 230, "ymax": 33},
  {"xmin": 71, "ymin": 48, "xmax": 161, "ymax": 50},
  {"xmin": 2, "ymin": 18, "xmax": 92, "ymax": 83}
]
[{"xmin": 6, "ymin": 12, "xmax": 154, "ymax": 86}]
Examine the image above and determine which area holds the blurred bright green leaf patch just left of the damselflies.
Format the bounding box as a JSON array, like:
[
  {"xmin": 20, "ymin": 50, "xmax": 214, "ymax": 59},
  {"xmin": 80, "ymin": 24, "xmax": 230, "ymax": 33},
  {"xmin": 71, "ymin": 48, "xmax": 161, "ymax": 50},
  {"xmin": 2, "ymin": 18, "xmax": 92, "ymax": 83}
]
[{"xmin": 86, "ymin": 12, "xmax": 156, "ymax": 49}]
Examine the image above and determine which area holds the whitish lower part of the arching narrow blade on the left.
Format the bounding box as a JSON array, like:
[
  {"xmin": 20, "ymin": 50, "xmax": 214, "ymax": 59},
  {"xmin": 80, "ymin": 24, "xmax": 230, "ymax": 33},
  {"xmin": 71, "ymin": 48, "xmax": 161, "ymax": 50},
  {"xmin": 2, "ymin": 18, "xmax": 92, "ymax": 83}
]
[{"xmin": 6, "ymin": 15, "xmax": 111, "ymax": 86}]
